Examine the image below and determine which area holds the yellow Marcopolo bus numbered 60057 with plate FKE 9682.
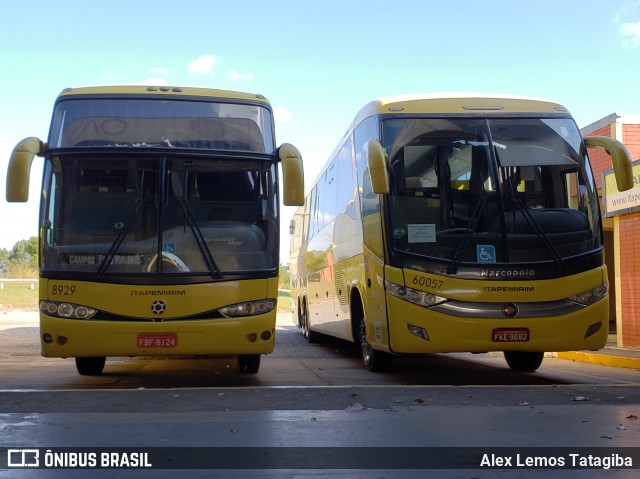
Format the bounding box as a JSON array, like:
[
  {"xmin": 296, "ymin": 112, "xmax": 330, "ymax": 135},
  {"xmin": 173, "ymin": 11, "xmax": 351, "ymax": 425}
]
[{"xmin": 290, "ymin": 95, "xmax": 632, "ymax": 371}]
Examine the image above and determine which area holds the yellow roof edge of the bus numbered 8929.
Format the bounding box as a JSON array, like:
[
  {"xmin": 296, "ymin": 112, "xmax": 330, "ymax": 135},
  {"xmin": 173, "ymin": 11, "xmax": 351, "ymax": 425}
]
[{"xmin": 58, "ymin": 85, "xmax": 269, "ymax": 105}]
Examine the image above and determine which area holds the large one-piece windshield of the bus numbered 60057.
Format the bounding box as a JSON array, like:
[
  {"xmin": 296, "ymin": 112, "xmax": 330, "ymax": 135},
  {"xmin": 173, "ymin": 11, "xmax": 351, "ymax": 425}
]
[{"xmin": 383, "ymin": 117, "xmax": 602, "ymax": 266}]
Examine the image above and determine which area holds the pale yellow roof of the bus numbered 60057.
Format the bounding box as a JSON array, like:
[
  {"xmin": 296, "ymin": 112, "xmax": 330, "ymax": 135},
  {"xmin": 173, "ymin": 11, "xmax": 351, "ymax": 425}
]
[{"xmin": 353, "ymin": 93, "xmax": 567, "ymax": 126}]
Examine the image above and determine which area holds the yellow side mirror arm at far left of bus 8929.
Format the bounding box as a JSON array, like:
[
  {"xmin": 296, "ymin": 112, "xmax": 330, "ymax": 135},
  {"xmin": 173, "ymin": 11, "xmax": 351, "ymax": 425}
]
[{"xmin": 6, "ymin": 137, "xmax": 47, "ymax": 203}]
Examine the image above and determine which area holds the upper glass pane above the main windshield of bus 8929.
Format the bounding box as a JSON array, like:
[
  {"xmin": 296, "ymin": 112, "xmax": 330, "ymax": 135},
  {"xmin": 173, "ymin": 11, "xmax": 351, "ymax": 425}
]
[{"xmin": 49, "ymin": 97, "xmax": 275, "ymax": 154}]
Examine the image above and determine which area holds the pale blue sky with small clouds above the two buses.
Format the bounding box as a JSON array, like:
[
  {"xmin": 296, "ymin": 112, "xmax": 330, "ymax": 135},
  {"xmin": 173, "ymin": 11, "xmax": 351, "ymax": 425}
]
[{"xmin": 0, "ymin": 0, "xmax": 640, "ymax": 263}]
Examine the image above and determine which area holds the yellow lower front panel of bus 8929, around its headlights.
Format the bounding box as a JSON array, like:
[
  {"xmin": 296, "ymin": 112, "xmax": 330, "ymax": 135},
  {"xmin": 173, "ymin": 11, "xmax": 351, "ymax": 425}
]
[{"xmin": 40, "ymin": 278, "xmax": 278, "ymax": 358}]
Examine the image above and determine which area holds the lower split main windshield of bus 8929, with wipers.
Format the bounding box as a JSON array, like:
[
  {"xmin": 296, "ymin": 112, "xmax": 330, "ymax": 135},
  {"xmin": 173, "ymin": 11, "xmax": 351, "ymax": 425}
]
[{"xmin": 42, "ymin": 157, "xmax": 278, "ymax": 278}]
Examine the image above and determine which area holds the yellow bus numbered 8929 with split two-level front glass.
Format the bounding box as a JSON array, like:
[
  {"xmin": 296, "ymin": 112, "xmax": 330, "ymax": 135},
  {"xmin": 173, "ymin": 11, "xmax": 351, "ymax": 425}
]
[{"xmin": 7, "ymin": 86, "xmax": 304, "ymax": 375}]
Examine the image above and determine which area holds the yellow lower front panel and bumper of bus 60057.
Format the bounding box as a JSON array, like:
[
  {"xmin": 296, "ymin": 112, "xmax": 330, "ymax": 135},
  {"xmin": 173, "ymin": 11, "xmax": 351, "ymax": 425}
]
[{"xmin": 386, "ymin": 266, "xmax": 609, "ymax": 353}]
